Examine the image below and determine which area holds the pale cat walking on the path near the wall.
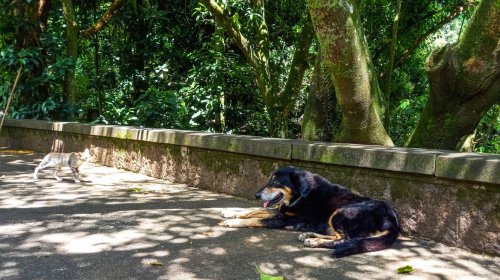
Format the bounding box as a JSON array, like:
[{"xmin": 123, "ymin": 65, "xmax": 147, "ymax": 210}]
[{"xmin": 33, "ymin": 149, "xmax": 90, "ymax": 183}]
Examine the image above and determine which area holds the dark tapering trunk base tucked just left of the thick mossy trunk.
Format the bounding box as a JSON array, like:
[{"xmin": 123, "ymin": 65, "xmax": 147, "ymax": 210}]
[{"xmin": 301, "ymin": 49, "xmax": 341, "ymax": 141}]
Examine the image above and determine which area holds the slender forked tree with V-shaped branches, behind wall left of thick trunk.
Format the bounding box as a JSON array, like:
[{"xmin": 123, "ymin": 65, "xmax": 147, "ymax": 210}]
[{"xmin": 200, "ymin": 0, "xmax": 314, "ymax": 138}]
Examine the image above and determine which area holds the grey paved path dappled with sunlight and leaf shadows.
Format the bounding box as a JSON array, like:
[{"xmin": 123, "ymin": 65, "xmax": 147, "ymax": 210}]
[{"xmin": 0, "ymin": 150, "xmax": 500, "ymax": 280}]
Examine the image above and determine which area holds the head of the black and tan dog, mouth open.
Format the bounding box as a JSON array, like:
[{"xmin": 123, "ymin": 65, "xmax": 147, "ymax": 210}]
[{"xmin": 255, "ymin": 167, "xmax": 312, "ymax": 208}]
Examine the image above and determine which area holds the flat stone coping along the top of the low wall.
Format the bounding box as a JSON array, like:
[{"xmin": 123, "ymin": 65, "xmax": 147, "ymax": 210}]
[{"xmin": 5, "ymin": 119, "xmax": 500, "ymax": 184}]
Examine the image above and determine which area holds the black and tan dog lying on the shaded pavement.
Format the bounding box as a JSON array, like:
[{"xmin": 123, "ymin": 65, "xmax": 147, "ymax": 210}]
[{"xmin": 221, "ymin": 167, "xmax": 400, "ymax": 258}]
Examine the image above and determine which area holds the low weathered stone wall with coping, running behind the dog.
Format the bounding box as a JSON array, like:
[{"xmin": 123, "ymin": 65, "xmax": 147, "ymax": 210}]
[{"xmin": 2, "ymin": 120, "xmax": 500, "ymax": 255}]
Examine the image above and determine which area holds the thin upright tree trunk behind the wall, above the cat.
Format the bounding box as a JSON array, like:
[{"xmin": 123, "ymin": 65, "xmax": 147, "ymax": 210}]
[{"xmin": 61, "ymin": 0, "xmax": 79, "ymax": 110}]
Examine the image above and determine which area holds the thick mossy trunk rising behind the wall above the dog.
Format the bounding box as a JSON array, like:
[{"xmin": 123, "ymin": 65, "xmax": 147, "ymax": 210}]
[{"xmin": 307, "ymin": 0, "xmax": 393, "ymax": 146}]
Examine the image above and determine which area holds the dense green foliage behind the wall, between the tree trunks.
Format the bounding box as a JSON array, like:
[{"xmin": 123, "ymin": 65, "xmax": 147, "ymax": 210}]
[{"xmin": 0, "ymin": 0, "xmax": 500, "ymax": 153}]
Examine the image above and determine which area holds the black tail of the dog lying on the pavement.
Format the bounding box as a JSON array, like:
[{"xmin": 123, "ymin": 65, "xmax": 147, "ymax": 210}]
[{"xmin": 332, "ymin": 226, "xmax": 399, "ymax": 258}]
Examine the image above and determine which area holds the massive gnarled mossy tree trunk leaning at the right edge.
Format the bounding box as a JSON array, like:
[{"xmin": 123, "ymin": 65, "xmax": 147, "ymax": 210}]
[{"xmin": 407, "ymin": 0, "xmax": 500, "ymax": 150}]
